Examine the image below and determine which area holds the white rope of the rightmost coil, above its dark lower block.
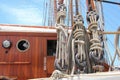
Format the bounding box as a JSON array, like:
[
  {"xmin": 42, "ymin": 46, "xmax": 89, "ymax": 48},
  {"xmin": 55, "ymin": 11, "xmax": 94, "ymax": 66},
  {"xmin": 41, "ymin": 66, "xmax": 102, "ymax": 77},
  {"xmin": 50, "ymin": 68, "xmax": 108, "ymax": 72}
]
[{"xmin": 88, "ymin": 11, "xmax": 102, "ymax": 51}]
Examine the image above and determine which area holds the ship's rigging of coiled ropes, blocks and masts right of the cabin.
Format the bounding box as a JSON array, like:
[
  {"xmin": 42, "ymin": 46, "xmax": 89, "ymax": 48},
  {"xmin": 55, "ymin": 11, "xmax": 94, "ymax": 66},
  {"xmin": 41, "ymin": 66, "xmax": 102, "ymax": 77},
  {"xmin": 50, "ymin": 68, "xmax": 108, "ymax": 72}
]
[{"xmin": 38, "ymin": 0, "xmax": 120, "ymax": 79}]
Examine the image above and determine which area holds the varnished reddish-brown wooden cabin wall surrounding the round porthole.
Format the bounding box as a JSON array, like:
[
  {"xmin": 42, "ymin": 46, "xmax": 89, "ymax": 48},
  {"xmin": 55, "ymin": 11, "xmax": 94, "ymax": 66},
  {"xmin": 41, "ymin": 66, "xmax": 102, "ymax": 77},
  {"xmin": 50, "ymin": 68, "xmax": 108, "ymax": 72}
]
[{"xmin": 0, "ymin": 32, "xmax": 56, "ymax": 80}]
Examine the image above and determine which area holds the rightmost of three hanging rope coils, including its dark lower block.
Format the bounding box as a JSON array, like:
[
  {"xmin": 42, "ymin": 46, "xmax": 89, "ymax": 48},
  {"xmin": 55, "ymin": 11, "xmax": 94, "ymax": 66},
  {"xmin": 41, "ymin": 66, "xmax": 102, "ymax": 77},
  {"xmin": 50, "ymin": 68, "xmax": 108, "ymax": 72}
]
[{"xmin": 87, "ymin": 10, "xmax": 104, "ymax": 71}]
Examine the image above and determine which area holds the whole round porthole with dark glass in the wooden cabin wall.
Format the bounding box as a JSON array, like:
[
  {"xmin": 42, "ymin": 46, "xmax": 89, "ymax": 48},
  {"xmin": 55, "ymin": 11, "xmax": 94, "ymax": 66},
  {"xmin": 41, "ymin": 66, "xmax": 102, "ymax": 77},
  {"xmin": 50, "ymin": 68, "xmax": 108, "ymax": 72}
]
[{"xmin": 16, "ymin": 39, "xmax": 30, "ymax": 52}]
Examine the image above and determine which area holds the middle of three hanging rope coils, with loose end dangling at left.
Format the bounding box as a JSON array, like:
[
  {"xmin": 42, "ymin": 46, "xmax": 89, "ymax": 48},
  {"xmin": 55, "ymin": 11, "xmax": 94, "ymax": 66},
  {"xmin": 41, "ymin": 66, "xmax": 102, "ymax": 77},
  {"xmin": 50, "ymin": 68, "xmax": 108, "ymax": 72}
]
[{"xmin": 71, "ymin": 15, "xmax": 86, "ymax": 74}]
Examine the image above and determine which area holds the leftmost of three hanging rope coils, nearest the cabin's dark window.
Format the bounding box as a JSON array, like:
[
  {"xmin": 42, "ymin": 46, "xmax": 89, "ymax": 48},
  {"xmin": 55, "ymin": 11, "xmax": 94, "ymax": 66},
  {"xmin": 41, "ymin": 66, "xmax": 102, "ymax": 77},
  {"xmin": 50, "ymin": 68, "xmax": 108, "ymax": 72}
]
[{"xmin": 55, "ymin": 4, "xmax": 68, "ymax": 71}]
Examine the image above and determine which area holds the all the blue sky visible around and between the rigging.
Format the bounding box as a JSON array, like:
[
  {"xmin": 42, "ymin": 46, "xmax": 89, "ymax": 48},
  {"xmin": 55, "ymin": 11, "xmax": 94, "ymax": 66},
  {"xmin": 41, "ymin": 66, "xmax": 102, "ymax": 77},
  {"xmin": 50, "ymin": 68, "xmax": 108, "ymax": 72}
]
[{"xmin": 0, "ymin": 0, "xmax": 120, "ymax": 64}]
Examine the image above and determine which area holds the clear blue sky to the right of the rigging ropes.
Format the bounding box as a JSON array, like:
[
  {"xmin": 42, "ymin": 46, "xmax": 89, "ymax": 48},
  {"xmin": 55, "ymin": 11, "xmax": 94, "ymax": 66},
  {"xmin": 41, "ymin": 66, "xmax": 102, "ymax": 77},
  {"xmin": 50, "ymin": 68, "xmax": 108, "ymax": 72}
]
[{"xmin": 103, "ymin": 0, "xmax": 120, "ymax": 66}]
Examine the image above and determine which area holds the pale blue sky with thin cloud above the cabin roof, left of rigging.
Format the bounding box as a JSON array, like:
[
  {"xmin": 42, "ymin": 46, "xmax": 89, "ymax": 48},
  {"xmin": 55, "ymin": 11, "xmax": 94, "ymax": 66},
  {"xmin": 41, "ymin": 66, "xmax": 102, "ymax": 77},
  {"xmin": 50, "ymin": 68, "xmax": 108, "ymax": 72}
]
[{"xmin": 0, "ymin": 0, "xmax": 43, "ymax": 25}]
